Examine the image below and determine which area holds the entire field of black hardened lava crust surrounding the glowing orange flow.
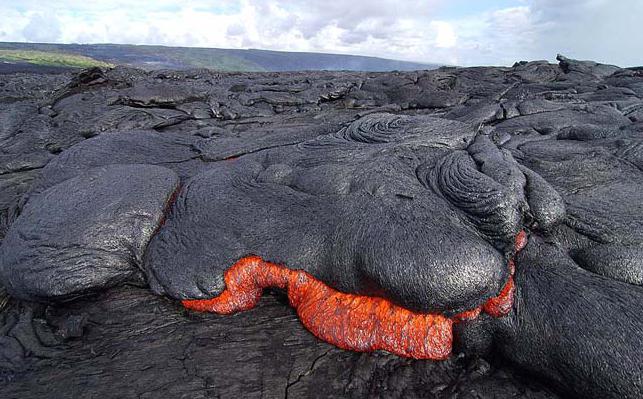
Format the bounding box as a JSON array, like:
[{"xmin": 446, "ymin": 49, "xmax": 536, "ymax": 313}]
[{"xmin": 0, "ymin": 56, "xmax": 643, "ymax": 398}]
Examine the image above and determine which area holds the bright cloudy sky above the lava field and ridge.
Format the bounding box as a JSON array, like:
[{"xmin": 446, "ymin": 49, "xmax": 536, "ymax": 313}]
[{"xmin": 0, "ymin": 0, "xmax": 643, "ymax": 66}]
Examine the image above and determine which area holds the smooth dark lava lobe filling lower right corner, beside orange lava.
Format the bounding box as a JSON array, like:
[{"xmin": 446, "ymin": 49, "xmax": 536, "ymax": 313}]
[{"xmin": 496, "ymin": 240, "xmax": 643, "ymax": 398}]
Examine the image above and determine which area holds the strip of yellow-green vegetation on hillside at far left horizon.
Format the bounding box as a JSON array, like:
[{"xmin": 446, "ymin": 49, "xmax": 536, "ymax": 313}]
[{"xmin": 0, "ymin": 49, "xmax": 113, "ymax": 68}]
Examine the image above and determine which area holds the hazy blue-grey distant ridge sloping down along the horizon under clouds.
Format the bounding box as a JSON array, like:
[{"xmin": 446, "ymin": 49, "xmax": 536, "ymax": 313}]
[{"xmin": 0, "ymin": 42, "xmax": 440, "ymax": 72}]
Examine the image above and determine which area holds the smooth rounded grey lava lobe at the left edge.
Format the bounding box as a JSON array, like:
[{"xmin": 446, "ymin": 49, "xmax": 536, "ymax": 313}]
[{"xmin": 0, "ymin": 165, "xmax": 178, "ymax": 299}]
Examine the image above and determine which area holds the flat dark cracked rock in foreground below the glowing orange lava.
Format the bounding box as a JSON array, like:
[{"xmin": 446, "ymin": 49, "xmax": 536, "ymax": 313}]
[{"xmin": 0, "ymin": 287, "xmax": 558, "ymax": 399}]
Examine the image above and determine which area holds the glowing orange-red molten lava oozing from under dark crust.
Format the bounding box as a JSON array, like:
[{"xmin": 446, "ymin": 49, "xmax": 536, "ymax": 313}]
[{"xmin": 183, "ymin": 232, "xmax": 527, "ymax": 360}]
